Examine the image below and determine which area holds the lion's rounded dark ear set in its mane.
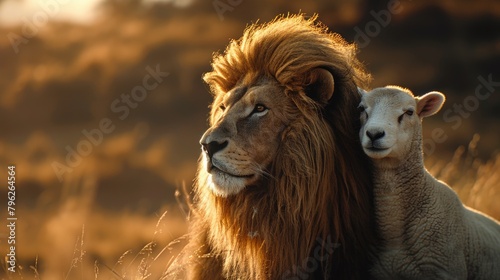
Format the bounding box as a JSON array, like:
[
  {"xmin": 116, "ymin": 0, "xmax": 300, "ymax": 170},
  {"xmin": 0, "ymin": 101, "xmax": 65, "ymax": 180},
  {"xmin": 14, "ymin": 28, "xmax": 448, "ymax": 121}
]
[{"xmin": 304, "ymin": 68, "xmax": 335, "ymax": 104}]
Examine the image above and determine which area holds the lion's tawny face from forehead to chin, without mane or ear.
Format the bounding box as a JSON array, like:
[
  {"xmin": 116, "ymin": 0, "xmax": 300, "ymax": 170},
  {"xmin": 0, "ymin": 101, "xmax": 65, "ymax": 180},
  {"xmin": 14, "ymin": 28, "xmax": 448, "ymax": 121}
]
[{"xmin": 200, "ymin": 76, "xmax": 292, "ymax": 196}]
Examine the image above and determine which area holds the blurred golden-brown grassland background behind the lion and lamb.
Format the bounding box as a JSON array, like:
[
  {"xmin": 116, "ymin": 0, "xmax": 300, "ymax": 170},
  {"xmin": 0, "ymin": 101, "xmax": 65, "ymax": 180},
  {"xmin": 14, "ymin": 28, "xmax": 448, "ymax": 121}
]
[{"xmin": 0, "ymin": 0, "xmax": 500, "ymax": 279}]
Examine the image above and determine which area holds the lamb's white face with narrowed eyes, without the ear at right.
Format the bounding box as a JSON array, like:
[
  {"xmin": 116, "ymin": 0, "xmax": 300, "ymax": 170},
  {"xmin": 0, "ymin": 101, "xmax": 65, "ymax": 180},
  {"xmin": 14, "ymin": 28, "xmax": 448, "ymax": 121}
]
[{"xmin": 359, "ymin": 87, "xmax": 420, "ymax": 160}]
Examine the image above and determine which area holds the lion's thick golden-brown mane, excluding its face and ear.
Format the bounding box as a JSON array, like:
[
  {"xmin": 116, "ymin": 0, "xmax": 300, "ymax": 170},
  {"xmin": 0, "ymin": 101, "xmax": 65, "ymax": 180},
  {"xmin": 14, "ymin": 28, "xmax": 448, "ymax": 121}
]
[{"xmin": 187, "ymin": 15, "xmax": 375, "ymax": 279}]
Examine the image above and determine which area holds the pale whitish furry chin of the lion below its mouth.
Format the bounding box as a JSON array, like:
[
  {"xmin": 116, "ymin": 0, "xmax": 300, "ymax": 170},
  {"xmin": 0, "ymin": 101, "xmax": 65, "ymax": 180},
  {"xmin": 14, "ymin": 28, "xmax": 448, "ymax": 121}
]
[{"xmin": 208, "ymin": 172, "xmax": 248, "ymax": 197}]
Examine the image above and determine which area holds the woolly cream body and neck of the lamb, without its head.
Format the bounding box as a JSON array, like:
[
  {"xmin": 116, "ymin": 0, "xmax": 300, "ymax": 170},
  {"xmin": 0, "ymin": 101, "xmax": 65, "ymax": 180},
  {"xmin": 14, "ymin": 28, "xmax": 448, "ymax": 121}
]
[{"xmin": 373, "ymin": 148, "xmax": 500, "ymax": 279}]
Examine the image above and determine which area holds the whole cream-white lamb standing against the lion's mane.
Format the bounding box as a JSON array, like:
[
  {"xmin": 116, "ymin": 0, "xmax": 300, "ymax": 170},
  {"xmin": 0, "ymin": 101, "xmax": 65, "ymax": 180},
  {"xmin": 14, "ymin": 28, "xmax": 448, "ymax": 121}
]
[{"xmin": 359, "ymin": 86, "xmax": 500, "ymax": 279}]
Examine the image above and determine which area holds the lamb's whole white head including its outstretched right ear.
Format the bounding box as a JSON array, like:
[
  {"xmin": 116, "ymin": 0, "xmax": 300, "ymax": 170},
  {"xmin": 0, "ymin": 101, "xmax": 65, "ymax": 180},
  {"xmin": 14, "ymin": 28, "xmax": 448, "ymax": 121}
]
[{"xmin": 359, "ymin": 86, "xmax": 445, "ymax": 167}]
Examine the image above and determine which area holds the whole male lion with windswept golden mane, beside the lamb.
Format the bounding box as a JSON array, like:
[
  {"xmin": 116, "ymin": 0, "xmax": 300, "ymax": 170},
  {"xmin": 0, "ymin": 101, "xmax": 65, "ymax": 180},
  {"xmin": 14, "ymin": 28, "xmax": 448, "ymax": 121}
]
[{"xmin": 185, "ymin": 15, "xmax": 376, "ymax": 279}]
